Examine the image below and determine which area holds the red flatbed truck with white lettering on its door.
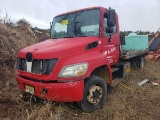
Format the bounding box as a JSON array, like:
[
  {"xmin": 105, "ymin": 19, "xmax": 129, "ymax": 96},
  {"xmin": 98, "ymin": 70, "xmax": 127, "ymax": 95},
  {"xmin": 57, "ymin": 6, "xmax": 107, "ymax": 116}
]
[{"xmin": 16, "ymin": 7, "xmax": 146, "ymax": 112}]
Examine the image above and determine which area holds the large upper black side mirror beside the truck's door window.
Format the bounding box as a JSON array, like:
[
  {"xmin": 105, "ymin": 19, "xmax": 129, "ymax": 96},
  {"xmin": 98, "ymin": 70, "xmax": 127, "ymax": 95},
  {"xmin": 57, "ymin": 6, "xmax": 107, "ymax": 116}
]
[{"xmin": 104, "ymin": 8, "xmax": 116, "ymax": 27}]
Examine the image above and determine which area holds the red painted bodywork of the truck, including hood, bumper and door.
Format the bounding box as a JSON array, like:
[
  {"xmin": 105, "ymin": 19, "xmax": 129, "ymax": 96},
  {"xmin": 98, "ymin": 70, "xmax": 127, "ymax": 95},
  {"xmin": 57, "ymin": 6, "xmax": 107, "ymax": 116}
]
[{"xmin": 16, "ymin": 7, "xmax": 120, "ymax": 102}]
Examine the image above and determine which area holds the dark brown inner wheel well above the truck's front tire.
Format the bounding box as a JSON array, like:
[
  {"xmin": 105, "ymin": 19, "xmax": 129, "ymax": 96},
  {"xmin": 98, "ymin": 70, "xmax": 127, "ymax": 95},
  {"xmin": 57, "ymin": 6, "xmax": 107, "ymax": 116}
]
[{"xmin": 91, "ymin": 65, "xmax": 110, "ymax": 85}]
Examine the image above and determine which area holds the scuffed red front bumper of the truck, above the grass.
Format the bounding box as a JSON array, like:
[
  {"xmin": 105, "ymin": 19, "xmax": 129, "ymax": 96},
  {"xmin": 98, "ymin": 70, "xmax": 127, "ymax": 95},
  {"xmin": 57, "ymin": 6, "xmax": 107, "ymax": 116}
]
[{"xmin": 16, "ymin": 76, "xmax": 84, "ymax": 102}]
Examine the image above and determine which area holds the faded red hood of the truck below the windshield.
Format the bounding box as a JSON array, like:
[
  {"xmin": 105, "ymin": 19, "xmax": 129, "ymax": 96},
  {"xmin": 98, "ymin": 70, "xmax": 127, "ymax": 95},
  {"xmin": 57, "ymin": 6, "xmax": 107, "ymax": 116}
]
[{"xmin": 18, "ymin": 37, "xmax": 99, "ymax": 59}]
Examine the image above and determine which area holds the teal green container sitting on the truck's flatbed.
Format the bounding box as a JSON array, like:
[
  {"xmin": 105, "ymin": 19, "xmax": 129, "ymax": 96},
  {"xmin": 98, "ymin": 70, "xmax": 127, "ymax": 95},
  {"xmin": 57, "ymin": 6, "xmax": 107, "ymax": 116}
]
[{"xmin": 122, "ymin": 33, "xmax": 149, "ymax": 51}]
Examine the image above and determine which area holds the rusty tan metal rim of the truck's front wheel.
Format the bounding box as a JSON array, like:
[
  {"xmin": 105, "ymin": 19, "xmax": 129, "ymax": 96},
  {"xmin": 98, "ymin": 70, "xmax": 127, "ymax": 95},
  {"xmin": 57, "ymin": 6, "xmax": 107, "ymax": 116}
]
[{"xmin": 87, "ymin": 85, "xmax": 103, "ymax": 106}]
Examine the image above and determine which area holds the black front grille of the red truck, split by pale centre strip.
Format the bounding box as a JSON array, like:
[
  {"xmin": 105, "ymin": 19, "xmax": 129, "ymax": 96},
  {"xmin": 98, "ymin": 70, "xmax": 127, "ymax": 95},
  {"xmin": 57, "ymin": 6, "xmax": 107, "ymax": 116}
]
[{"xmin": 17, "ymin": 58, "xmax": 58, "ymax": 74}]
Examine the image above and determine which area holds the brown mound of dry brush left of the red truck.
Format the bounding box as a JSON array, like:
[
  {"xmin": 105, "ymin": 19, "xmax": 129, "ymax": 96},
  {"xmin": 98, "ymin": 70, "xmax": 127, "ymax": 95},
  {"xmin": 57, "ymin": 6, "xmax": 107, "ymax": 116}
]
[{"xmin": 0, "ymin": 19, "xmax": 49, "ymax": 101}]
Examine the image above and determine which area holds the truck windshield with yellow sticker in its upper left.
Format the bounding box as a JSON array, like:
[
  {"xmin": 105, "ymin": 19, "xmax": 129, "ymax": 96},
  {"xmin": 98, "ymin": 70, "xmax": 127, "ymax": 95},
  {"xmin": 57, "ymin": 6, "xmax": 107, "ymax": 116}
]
[{"xmin": 51, "ymin": 9, "xmax": 100, "ymax": 38}]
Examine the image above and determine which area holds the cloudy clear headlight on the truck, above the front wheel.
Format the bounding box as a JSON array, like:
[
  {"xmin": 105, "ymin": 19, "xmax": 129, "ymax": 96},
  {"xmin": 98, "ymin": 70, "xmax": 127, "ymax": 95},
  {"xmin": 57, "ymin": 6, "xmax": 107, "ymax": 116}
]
[{"xmin": 59, "ymin": 63, "xmax": 88, "ymax": 78}]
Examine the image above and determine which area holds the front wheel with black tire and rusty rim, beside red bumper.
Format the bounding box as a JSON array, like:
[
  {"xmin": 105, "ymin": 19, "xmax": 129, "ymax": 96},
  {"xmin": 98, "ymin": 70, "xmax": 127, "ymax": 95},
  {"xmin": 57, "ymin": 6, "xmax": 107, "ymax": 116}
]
[{"xmin": 78, "ymin": 75, "xmax": 107, "ymax": 112}]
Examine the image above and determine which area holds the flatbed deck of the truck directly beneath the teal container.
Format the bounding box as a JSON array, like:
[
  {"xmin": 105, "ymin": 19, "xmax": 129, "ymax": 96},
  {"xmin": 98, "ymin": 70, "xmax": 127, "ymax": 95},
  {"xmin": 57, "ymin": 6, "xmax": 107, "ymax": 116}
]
[{"xmin": 120, "ymin": 49, "xmax": 149, "ymax": 59}]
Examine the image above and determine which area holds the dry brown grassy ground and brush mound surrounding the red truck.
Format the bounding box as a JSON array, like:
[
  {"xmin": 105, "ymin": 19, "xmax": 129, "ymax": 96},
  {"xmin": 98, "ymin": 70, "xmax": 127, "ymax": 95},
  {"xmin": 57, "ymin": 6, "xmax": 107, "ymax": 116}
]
[{"xmin": 0, "ymin": 21, "xmax": 160, "ymax": 120}]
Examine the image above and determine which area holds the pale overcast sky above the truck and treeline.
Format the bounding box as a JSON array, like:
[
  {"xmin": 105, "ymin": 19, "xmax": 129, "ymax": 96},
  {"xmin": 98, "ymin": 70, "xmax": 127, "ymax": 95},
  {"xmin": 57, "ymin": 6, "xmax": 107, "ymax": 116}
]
[{"xmin": 0, "ymin": 0, "xmax": 160, "ymax": 31}]
